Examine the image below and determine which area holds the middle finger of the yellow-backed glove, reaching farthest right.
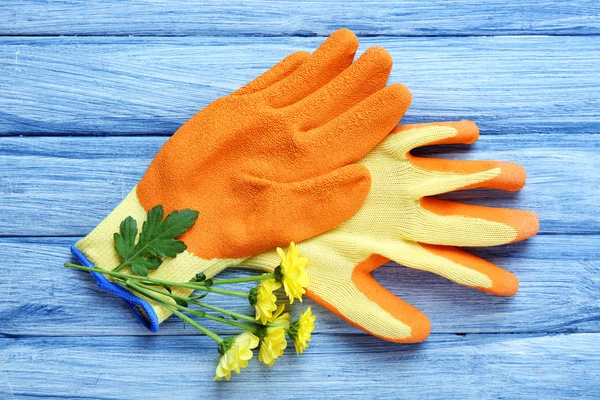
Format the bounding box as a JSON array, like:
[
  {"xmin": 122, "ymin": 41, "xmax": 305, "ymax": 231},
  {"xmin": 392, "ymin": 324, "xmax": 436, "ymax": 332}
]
[{"xmin": 402, "ymin": 197, "xmax": 539, "ymax": 246}]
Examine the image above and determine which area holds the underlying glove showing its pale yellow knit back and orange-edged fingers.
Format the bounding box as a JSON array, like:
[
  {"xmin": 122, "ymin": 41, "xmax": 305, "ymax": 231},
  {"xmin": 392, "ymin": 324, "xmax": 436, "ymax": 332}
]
[{"xmin": 244, "ymin": 121, "xmax": 539, "ymax": 343}]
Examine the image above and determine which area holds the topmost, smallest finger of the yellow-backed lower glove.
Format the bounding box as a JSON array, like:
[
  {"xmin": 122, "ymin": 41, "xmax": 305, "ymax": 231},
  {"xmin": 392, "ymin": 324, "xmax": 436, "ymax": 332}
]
[{"xmin": 384, "ymin": 121, "xmax": 479, "ymax": 159}]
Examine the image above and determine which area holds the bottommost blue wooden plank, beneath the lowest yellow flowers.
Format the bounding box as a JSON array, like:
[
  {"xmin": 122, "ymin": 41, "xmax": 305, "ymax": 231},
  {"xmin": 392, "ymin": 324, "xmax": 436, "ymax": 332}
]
[{"xmin": 0, "ymin": 334, "xmax": 600, "ymax": 400}]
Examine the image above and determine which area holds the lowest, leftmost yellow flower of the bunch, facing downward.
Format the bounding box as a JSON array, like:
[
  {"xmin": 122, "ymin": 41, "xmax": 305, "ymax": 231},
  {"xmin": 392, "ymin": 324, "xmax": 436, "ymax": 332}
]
[{"xmin": 214, "ymin": 331, "xmax": 259, "ymax": 381}]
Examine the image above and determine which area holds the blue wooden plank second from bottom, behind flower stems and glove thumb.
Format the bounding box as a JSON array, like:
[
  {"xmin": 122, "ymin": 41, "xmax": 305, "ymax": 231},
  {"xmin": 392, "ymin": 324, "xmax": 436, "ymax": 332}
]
[{"xmin": 0, "ymin": 235, "xmax": 600, "ymax": 337}]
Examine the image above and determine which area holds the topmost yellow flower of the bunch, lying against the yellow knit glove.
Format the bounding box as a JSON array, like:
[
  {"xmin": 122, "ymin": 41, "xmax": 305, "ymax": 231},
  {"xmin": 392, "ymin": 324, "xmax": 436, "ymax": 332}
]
[{"xmin": 275, "ymin": 242, "xmax": 308, "ymax": 304}]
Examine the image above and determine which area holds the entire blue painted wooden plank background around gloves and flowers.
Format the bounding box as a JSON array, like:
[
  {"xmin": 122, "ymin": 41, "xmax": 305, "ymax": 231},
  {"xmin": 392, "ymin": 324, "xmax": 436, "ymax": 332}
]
[{"xmin": 0, "ymin": 0, "xmax": 600, "ymax": 399}]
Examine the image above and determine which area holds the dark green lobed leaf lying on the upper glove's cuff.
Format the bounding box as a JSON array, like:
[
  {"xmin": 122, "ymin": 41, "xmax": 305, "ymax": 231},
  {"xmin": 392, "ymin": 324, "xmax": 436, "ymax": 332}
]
[{"xmin": 114, "ymin": 205, "xmax": 198, "ymax": 276}]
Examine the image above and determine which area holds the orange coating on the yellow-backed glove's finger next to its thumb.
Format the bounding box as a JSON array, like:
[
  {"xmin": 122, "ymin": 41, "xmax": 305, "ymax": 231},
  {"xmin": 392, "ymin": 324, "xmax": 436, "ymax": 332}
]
[{"xmin": 419, "ymin": 243, "xmax": 519, "ymax": 296}]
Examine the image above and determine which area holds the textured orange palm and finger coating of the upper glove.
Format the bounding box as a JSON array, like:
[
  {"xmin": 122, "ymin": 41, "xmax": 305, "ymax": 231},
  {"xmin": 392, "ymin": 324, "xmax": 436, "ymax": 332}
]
[{"xmin": 137, "ymin": 29, "xmax": 411, "ymax": 259}]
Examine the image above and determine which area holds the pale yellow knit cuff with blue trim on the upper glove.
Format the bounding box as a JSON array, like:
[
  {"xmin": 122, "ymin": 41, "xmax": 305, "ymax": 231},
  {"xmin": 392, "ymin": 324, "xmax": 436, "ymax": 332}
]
[{"xmin": 71, "ymin": 187, "xmax": 244, "ymax": 332}]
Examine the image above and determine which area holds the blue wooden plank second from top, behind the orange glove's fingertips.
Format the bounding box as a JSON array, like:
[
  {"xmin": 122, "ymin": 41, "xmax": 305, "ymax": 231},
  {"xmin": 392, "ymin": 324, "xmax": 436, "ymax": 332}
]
[{"xmin": 0, "ymin": 35, "xmax": 600, "ymax": 135}]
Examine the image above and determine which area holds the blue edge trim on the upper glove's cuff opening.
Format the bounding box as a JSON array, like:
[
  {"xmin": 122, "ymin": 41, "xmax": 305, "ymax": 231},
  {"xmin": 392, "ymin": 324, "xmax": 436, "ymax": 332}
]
[{"xmin": 71, "ymin": 245, "xmax": 159, "ymax": 333}]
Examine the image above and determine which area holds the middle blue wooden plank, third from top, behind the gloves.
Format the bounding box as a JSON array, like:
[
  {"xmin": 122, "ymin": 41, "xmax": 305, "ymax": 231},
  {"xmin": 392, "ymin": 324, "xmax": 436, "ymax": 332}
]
[{"xmin": 0, "ymin": 132, "xmax": 600, "ymax": 236}]
